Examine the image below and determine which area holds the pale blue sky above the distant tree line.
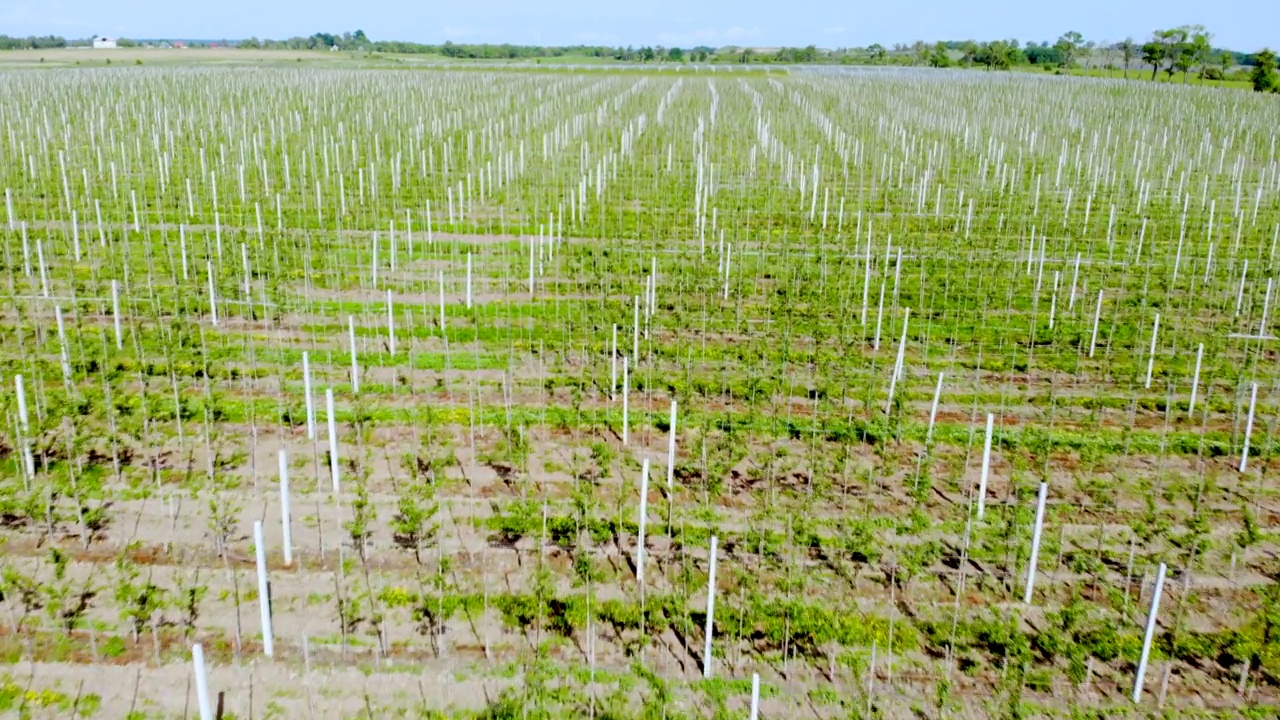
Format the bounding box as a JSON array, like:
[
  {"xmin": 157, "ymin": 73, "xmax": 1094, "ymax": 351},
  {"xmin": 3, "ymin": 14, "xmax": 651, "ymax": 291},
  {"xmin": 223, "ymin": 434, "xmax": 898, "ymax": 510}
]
[{"xmin": 0, "ymin": 0, "xmax": 1280, "ymax": 50}]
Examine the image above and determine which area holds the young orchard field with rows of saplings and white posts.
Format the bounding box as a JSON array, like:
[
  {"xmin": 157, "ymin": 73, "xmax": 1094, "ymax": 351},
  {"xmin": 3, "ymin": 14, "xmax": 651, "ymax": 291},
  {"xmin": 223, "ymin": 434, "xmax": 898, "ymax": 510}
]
[{"xmin": 0, "ymin": 64, "xmax": 1280, "ymax": 717}]
